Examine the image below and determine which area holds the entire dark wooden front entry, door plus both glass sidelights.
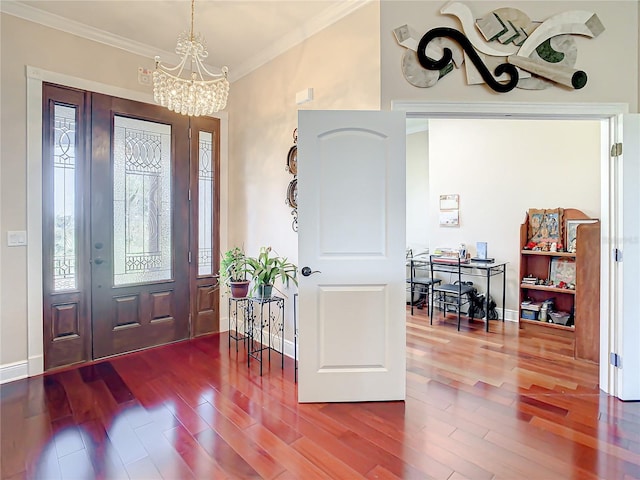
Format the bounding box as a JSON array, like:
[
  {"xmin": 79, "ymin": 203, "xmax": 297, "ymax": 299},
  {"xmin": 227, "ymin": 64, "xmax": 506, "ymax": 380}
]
[{"xmin": 43, "ymin": 85, "xmax": 219, "ymax": 369}]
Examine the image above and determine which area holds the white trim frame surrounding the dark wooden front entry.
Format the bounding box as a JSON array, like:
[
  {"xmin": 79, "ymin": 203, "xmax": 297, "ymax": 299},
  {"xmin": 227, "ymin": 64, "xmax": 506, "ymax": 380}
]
[{"xmin": 25, "ymin": 65, "xmax": 229, "ymax": 378}]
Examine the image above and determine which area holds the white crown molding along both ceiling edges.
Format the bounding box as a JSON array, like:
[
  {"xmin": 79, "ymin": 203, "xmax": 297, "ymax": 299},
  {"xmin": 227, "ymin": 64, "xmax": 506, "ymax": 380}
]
[{"xmin": 0, "ymin": 0, "xmax": 373, "ymax": 82}]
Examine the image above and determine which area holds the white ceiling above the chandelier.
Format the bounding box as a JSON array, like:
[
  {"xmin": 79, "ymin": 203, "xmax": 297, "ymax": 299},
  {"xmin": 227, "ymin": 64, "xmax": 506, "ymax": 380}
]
[{"xmin": 0, "ymin": 0, "xmax": 370, "ymax": 81}]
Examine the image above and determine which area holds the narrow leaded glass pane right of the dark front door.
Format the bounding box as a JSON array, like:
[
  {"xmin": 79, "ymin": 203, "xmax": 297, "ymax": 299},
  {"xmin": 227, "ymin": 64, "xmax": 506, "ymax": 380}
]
[{"xmin": 198, "ymin": 132, "xmax": 214, "ymax": 275}]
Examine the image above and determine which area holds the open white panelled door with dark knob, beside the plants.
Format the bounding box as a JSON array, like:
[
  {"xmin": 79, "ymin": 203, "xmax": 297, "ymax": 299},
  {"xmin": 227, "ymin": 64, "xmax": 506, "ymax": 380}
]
[{"xmin": 298, "ymin": 111, "xmax": 406, "ymax": 402}]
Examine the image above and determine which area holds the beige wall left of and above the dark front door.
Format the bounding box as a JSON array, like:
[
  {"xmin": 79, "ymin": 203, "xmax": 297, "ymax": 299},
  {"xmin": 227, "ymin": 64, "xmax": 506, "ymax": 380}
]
[{"xmin": 0, "ymin": 14, "xmax": 159, "ymax": 365}]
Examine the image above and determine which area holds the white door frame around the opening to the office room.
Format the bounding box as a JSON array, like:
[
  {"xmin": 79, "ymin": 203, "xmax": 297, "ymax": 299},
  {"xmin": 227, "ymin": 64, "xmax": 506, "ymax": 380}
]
[{"xmin": 391, "ymin": 101, "xmax": 629, "ymax": 395}]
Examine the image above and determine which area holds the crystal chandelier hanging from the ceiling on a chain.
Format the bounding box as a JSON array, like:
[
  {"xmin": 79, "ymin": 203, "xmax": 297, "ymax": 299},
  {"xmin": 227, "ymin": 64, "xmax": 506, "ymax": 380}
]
[{"xmin": 153, "ymin": 0, "xmax": 229, "ymax": 117}]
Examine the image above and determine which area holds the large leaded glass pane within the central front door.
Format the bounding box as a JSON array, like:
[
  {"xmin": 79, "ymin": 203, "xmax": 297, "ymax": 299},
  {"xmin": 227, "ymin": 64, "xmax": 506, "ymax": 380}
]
[{"xmin": 113, "ymin": 116, "xmax": 172, "ymax": 285}]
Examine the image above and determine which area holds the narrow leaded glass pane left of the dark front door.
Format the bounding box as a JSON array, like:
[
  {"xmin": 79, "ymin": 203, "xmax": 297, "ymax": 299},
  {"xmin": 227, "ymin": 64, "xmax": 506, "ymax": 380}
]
[{"xmin": 52, "ymin": 104, "xmax": 78, "ymax": 292}]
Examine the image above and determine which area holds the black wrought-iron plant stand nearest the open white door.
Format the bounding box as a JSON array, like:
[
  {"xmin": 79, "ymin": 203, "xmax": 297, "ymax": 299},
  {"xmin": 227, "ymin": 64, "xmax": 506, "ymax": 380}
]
[{"xmin": 247, "ymin": 297, "xmax": 284, "ymax": 376}]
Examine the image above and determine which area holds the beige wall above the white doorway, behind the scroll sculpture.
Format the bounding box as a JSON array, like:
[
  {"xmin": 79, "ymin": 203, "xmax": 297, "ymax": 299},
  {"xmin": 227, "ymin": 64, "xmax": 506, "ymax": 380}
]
[{"xmin": 380, "ymin": 0, "xmax": 640, "ymax": 112}]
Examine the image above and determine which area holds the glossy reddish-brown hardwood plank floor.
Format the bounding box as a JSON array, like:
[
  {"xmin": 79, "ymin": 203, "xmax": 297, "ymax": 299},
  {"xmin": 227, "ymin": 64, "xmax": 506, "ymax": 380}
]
[{"xmin": 0, "ymin": 310, "xmax": 640, "ymax": 480}]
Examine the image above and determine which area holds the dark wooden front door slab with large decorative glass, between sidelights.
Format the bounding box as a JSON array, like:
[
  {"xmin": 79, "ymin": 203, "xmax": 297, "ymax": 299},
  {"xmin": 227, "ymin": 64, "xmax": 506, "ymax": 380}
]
[{"xmin": 90, "ymin": 94, "xmax": 189, "ymax": 358}]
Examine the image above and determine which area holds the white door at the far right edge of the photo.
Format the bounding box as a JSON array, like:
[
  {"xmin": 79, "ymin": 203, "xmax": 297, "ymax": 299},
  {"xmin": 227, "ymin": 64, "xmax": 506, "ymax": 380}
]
[{"xmin": 613, "ymin": 114, "xmax": 640, "ymax": 400}]
